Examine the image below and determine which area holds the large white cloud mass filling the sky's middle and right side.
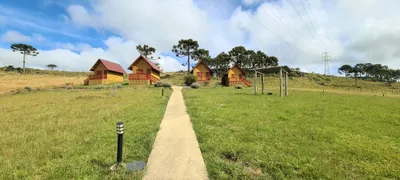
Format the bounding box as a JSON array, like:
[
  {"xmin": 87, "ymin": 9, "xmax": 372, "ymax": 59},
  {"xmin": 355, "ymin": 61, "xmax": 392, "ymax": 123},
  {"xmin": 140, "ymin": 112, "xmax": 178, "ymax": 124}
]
[{"xmin": 0, "ymin": 0, "xmax": 400, "ymax": 73}]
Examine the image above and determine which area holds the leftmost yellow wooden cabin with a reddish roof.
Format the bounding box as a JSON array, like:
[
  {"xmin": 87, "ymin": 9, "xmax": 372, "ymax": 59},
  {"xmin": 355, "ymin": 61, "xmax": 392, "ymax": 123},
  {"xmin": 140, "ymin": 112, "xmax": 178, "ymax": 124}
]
[{"xmin": 84, "ymin": 59, "xmax": 126, "ymax": 85}]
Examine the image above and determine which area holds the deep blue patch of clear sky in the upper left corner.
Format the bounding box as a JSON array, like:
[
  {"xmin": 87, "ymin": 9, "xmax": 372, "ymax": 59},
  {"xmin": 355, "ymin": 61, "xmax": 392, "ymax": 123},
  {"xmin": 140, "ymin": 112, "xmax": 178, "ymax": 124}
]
[{"xmin": 0, "ymin": 0, "xmax": 108, "ymax": 50}]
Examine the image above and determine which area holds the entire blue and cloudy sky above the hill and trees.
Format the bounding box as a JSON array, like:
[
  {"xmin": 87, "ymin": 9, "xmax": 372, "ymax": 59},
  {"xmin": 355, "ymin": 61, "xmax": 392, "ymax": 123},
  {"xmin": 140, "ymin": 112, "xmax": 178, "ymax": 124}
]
[{"xmin": 0, "ymin": 0, "xmax": 400, "ymax": 74}]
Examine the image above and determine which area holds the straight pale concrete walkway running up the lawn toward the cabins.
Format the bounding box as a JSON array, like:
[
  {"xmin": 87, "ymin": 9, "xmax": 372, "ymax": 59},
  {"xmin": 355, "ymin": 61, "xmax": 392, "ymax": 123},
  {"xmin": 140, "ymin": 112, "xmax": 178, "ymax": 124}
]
[{"xmin": 143, "ymin": 87, "xmax": 208, "ymax": 180}]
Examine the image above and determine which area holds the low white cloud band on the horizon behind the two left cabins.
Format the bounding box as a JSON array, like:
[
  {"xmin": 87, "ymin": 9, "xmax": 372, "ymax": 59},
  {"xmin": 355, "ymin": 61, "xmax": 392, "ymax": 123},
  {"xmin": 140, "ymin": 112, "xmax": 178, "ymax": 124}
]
[{"xmin": 0, "ymin": 37, "xmax": 186, "ymax": 72}]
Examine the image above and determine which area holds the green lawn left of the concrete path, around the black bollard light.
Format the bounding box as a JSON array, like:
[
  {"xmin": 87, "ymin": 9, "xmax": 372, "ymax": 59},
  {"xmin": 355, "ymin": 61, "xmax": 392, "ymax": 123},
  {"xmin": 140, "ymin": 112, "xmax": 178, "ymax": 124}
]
[{"xmin": 0, "ymin": 88, "xmax": 171, "ymax": 179}]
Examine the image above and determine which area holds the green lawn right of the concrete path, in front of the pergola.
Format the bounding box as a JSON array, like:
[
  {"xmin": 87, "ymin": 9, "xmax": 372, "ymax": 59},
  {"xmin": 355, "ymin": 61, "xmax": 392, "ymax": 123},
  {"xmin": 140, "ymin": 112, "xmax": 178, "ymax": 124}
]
[{"xmin": 183, "ymin": 88, "xmax": 400, "ymax": 179}]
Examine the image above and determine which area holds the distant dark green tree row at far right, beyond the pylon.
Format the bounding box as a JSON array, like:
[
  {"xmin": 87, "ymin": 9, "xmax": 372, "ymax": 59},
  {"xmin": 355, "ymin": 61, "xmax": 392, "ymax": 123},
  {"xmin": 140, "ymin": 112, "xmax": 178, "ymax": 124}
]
[{"xmin": 338, "ymin": 63, "xmax": 400, "ymax": 82}]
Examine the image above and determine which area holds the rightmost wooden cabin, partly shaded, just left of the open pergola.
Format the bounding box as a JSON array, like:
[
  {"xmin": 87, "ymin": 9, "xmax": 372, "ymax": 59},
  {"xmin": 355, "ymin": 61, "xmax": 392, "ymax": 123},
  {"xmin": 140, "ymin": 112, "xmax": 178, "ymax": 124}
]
[{"xmin": 222, "ymin": 64, "xmax": 251, "ymax": 87}]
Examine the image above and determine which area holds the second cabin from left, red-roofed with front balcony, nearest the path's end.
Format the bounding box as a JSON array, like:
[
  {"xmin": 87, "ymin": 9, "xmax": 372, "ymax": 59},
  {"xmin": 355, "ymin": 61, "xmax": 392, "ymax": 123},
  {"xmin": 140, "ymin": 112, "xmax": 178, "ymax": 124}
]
[{"xmin": 128, "ymin": 55, "xmax": 161, "ymax": 86}]
